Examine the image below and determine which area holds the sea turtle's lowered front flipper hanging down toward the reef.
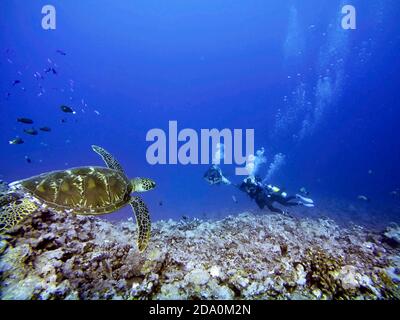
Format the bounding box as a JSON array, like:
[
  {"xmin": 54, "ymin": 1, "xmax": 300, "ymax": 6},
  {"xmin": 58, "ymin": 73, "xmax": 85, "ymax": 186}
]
[{"xmin": 130, "ymin": 197, "xmax": 151, "ymax": 252}]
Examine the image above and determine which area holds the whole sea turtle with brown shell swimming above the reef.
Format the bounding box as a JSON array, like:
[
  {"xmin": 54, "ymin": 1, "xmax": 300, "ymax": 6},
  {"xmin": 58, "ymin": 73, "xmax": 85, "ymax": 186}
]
[{"xmin": 0, "ymin": 146, "xmax": 155, "ymax": 252}]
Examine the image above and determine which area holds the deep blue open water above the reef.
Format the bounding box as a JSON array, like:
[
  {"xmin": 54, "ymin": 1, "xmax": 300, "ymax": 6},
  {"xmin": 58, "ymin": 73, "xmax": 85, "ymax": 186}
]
[{"xmin": 0, "ymin": 0, "xmax": 400, "ymax": 228}]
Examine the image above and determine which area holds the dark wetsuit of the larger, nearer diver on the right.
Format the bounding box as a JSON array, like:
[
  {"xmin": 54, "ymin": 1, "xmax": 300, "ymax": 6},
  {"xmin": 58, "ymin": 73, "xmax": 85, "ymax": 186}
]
[{"xmin": 239, "ymin": 178, "xmax": 301, "ymax": 214}]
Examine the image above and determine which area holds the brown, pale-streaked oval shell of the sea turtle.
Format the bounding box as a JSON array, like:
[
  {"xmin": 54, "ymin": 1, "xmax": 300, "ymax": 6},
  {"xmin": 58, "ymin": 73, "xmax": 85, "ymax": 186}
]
[{"xmin": 13, "ymin": 167, "xmax": 132, "ymax": 215}]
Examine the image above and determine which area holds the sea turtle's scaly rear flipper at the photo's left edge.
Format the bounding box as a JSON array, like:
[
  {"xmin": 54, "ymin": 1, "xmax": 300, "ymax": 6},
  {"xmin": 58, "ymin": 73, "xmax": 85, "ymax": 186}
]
[{"xmin": 0, "ymin": 199, "xmax": 38, "ymax": 233}]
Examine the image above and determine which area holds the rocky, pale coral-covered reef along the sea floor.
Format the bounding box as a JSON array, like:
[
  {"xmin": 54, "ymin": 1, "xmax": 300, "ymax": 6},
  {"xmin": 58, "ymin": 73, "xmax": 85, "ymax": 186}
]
[{"xmin": 0, "ymin": 211, "xmax": 400, "ymax": 299}]
